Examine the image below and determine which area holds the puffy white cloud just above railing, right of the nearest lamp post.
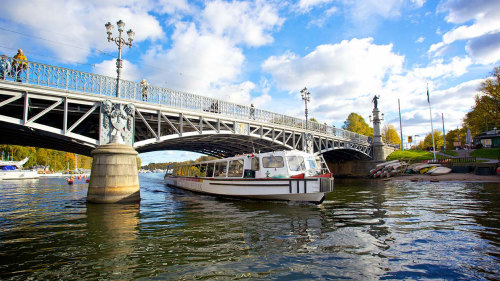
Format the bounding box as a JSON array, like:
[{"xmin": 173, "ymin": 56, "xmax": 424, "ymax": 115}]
[{"xmin": 143, "ymin": 23, "xmax": 245, "ymax": 93}]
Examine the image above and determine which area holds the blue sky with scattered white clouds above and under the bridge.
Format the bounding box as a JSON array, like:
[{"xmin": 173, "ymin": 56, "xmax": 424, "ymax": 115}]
[{"xmin": 0, "ymin": 0, "xmax": 500, "ymax": 164}]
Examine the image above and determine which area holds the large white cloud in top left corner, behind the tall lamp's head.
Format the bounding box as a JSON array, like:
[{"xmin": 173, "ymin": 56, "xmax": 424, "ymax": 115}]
[{"xmin": 0, "ymin": 0, "xmax": 164, "ymax": 62}]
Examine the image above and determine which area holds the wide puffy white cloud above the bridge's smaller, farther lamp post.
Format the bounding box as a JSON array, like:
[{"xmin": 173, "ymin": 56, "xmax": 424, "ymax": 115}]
[{"xmin": 262, "ymin": 38, "xmax": 404, "ymax": 98}]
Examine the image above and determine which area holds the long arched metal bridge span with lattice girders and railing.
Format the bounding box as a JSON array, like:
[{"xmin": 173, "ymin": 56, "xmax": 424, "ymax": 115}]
[{"xmin": 0, "ymin": 58, "xmax": 372, "ymax": 159}]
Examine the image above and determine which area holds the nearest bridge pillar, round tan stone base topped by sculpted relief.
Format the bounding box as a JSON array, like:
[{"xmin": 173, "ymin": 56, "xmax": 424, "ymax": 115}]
[{"xmin": 87, "ymin": 100, "xmax": 141, "ymax": 203}]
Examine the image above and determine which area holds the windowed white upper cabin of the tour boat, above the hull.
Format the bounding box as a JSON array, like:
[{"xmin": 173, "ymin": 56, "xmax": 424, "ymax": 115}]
[{"xmin": 172, "ymin": 150, "xmax": 330, "ymax": 178}]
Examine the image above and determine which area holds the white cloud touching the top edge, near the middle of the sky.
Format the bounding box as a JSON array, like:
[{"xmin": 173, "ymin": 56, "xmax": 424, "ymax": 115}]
[{"xmin": 200, "ymin": 0, "xmax": 284, "ymax": 46}]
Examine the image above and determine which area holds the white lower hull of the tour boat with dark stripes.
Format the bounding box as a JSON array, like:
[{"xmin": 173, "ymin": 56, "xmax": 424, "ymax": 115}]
[{"xmin": 165, "ymin": 176, "xmax": 333, "ymax": 204}]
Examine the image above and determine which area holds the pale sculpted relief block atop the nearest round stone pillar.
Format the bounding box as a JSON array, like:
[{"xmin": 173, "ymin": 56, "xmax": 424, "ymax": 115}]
[{"xmin": 99, "ymin": 100, "xmax": 135, "ymax": 146}]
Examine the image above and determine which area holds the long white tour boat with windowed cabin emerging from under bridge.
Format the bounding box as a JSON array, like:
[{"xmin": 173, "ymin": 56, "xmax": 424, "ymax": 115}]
[{"xmin": 165, "ymin": 150, "xmax": 333, "ymax": 204}]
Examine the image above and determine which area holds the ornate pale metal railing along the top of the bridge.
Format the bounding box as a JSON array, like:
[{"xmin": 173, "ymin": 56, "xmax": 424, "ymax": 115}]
[{"xmin": 0, "ymin": 57, "xmax": 369, "ymax": 143}]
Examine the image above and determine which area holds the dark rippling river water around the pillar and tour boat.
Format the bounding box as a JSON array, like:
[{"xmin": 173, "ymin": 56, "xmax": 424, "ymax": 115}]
[{"xmin": 0, "ymin": 174, "xmax": 500, "ymax": 280}]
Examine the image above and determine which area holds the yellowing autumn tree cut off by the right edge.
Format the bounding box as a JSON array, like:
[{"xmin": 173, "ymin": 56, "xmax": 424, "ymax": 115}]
[{"xmin": 464, "ymin": 66, "xmax": 500, "ymax": 136}]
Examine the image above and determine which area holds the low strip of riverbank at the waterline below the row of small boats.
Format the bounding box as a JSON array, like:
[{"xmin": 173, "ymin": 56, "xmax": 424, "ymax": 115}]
[{"xmin": 388, "ymin": 173, "xmax": 500, "ymax": 182}]
